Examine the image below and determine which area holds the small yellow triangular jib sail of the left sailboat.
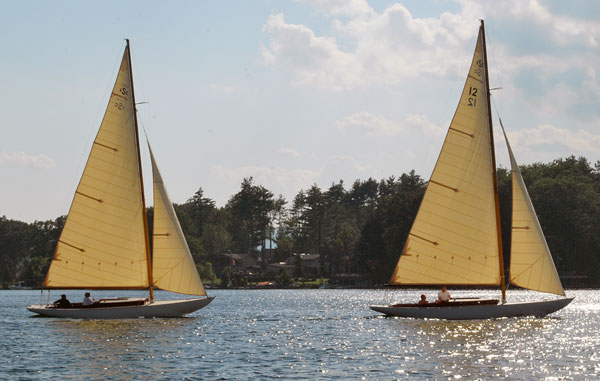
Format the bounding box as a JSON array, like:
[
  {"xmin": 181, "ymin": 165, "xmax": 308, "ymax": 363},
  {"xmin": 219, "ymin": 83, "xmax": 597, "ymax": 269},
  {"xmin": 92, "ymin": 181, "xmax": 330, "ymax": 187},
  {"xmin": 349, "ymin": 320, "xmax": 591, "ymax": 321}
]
[{"xmin": 148, "ymin": 143, "xmax": 206, "ymax": 296}]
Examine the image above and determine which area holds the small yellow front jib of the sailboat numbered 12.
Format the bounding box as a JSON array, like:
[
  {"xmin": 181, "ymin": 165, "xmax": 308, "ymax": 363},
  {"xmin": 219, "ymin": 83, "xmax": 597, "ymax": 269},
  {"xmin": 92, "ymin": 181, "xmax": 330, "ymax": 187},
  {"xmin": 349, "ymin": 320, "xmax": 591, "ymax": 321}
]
[{"xmin": 500, "ymin": 121, "xmax": 565, "ymax": 296}]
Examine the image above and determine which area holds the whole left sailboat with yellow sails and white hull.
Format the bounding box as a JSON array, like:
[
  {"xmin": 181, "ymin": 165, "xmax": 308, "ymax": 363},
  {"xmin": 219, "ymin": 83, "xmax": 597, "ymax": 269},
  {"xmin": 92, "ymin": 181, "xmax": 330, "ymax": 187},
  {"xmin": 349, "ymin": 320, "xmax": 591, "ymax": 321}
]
[{"xmin": 27, "ymin": 40, "xmax": 214, "ymax": 319}]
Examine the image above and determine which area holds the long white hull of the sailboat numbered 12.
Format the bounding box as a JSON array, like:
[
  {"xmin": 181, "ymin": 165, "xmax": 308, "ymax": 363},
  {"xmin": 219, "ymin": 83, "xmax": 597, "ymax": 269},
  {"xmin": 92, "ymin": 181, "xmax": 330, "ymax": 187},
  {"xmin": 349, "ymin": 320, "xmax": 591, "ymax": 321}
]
[{"xmin": 369, "ymin": 298, "xmax": 573, "ymax": 320}]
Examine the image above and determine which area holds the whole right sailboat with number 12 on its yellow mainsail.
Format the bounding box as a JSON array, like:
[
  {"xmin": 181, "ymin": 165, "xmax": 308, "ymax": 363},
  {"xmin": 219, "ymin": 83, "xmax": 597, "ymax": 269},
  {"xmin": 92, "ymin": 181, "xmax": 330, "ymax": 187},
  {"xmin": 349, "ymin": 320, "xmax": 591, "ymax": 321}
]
[{"xmin": 370, "ymin": 20, "xmax": 573, "ymax": 319}]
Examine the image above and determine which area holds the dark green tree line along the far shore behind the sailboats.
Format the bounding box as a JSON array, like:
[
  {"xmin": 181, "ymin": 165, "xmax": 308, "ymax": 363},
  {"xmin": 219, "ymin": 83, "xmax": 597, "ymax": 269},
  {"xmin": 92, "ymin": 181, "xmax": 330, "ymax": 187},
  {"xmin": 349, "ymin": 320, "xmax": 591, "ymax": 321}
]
[{"xmin": 0, "ymin": 156, "xmax": 600, "ymax": 287}]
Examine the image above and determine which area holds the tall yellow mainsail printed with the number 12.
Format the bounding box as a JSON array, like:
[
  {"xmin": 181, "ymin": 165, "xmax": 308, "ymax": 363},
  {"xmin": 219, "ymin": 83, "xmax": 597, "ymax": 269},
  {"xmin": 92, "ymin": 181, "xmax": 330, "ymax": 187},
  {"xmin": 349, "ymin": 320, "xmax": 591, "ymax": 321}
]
[{"xmin": 390, "ymin": 29, "xmax": 500, "ymax": 285}]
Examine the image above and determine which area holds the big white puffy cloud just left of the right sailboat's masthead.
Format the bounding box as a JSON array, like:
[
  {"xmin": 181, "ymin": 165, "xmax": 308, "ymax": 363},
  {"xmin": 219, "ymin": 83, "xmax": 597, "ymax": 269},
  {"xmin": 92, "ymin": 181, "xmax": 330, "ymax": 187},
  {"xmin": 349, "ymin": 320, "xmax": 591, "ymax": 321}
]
[{"xmin": 262, "ymin": 1, "xmax": 477, "ymax": 91}]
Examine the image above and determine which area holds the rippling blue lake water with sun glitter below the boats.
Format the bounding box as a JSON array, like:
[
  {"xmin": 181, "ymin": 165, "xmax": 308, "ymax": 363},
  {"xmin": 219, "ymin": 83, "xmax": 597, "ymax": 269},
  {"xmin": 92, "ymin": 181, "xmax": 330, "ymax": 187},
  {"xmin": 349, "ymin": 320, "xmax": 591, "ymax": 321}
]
[{"xmin": 0, "ymin": 290, "xmax": 600, "ymax": 380}]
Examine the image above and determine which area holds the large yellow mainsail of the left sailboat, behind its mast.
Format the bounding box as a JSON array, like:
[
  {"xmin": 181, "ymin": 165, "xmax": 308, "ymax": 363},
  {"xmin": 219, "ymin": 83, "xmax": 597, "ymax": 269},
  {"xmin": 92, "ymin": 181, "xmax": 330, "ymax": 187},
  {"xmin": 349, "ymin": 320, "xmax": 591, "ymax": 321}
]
[{"xmin": 44, "ymin": 47, "xmax": 149, "ymax": 289}]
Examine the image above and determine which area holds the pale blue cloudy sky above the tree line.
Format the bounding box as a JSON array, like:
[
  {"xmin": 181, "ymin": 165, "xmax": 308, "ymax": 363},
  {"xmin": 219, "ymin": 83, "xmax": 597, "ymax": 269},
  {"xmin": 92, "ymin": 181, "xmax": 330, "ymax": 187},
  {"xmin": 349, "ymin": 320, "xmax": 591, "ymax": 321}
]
[{"xmin": 0, "ymin": 0, "xmax": 600, "ymax": 222}]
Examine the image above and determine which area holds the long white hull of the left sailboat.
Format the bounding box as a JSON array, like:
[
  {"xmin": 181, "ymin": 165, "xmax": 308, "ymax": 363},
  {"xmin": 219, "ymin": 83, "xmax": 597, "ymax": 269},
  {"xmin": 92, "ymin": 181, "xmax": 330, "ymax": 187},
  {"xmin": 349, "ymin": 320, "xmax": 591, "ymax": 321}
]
[{"xmin": 27, "ymin": 297, "xmax": 214, "ymax": 319}]
